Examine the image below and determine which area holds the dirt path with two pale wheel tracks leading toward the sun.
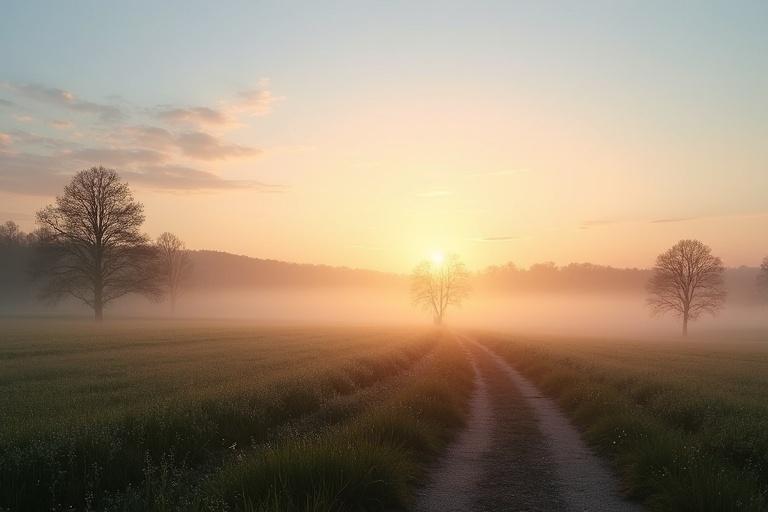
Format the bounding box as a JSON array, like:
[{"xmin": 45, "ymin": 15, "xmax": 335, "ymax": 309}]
[{"xmin": 415, "ymin": 340, "xmax": 641, "ymax": 512}]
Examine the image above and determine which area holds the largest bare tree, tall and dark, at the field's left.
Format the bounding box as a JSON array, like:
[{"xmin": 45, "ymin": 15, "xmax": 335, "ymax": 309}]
[{"xmin": 36, "ymin": 167, "xmax": 160, "ymax": 321}]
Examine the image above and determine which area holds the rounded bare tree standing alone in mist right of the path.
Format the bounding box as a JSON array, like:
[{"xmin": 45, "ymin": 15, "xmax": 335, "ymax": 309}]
[{"xmin": 648, "ymin": 240, "xmax": 726, "ymax": 336}]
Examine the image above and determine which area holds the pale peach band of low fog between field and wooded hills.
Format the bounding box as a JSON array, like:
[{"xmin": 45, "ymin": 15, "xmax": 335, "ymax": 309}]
[{"xmin": 68, "ymin": 287, "xmax": 768, "ymax": 338}]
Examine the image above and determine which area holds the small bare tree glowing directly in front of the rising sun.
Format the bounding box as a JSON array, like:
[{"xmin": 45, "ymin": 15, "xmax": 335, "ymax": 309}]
[{"xmin": 411, "ymin": 254, "xmax": 469, "ymax": 325}]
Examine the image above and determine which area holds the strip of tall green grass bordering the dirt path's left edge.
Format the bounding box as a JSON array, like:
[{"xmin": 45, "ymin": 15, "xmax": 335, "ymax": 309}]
[{"xmin": 209, "ymin": 336, "xmax": 473, "ymax": 512}]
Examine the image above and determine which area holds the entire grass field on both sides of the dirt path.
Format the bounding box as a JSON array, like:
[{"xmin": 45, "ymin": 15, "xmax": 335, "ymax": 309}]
[{"xmin": 7, "ymin": 320, "xmax": 768, "ymax": 512}]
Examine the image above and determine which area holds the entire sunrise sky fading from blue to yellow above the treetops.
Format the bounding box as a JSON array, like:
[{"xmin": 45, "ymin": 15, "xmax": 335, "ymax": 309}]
[{"xmin": 0, "ymin": 0, "xmax": 768, "ymax": 272}]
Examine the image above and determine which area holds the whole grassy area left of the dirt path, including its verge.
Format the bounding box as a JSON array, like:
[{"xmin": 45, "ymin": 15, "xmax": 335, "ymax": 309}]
[{"xmin": 0, "ymin": 320, "xmax": 472, "ymax": 510}]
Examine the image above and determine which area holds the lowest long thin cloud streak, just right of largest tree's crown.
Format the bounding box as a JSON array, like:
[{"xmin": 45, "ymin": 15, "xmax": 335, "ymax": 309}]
[{"xmin": 121, "ymin": 165, "xmax": 284, "ymax": 192}]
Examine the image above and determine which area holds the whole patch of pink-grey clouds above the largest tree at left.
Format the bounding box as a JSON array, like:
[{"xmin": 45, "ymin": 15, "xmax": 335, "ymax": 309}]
[{"xmin": 0, "ymin": 82, "xmax": 285, "ymax": 196}]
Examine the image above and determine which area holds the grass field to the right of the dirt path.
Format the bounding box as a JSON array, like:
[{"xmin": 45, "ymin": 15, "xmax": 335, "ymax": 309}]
[{"xmin": 480, "ymin": 333, "xmax": 768, "ymax": 511}]
